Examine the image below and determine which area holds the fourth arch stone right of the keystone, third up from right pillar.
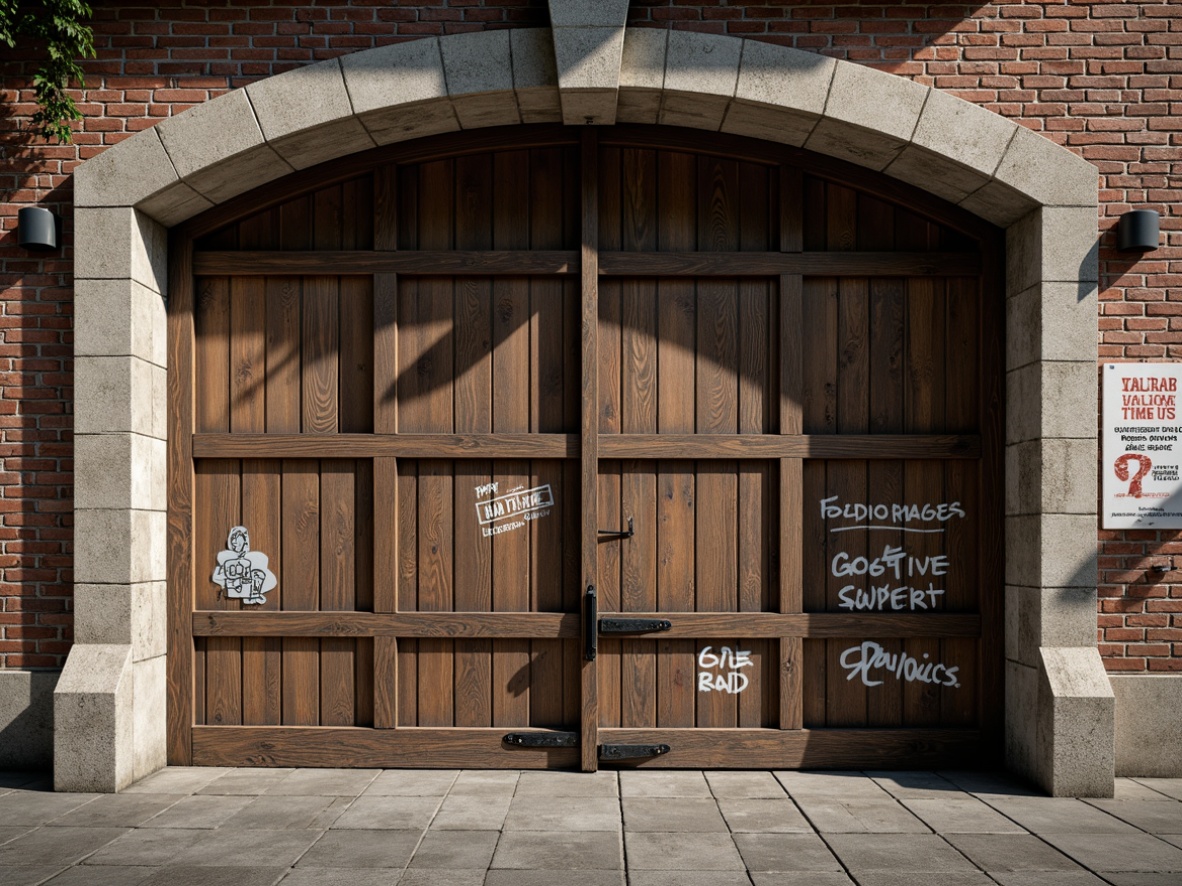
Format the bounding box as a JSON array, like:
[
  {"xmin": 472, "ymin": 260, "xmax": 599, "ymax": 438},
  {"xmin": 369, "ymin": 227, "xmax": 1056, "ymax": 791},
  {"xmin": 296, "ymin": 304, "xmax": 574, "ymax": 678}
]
[{"xmin": 805, "ymin": 61, "xmax": 929, "ymax": 169}]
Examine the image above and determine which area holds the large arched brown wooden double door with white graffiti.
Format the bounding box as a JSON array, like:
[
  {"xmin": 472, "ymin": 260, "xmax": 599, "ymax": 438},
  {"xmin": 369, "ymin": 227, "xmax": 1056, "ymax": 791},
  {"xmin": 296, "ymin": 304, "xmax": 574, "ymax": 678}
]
[{"xmin": 169, "ymin": 126, "xmax": 1004, "ymax": 770}]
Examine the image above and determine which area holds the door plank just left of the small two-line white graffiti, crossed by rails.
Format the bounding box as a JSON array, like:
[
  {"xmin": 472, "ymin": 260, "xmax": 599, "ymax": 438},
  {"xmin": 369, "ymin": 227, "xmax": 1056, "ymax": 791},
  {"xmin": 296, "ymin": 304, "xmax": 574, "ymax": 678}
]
[{"xmin": 657, "ymin": 152, "xmax": 697, "ymax": 727}]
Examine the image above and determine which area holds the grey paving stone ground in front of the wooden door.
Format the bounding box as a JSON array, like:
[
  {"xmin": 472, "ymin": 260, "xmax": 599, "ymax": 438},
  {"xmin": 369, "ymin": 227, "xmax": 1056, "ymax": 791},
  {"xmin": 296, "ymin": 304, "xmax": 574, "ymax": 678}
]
[{"xmin": 0, "ymin": 768, "xmax": 1182, "ymax": 886}]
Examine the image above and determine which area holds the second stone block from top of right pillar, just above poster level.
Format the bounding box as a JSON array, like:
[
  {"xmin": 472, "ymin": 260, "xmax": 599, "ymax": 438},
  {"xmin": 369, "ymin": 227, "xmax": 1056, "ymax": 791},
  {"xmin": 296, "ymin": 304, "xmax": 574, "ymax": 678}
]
[{"xmin": 1006, "ymin": 282, "xmax": 1098, "ymax": 370}]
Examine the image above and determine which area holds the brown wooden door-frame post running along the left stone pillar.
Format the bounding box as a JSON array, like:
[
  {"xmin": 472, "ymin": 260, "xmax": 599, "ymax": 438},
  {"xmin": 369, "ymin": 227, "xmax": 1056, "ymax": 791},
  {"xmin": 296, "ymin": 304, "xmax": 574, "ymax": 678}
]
[{"xmin": 165, "ymin": 235, "xmax": 195, "ymax": 766}]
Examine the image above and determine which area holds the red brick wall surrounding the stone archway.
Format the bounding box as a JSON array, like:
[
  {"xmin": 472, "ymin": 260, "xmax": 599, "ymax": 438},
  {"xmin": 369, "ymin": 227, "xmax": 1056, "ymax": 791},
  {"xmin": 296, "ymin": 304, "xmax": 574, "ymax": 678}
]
[{"xmin": 0, "ymin": 0, "xmax": 1182, "ymax": 671}]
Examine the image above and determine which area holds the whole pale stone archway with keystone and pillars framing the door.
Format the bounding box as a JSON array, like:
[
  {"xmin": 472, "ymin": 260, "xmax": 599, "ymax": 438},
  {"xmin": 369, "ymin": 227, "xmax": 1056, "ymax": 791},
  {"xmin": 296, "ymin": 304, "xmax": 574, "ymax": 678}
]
[{"xmin": 64, "ymin": 19, "xmax": 1113, "ymax": 796}]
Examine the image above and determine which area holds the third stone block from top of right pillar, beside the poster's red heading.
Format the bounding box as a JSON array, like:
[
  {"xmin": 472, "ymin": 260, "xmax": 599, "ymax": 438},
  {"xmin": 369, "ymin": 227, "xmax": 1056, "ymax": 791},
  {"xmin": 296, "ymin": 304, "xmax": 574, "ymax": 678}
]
[{"xmin": 1006, "ymin": 361, "xmax": 1096, "ymax": 443}]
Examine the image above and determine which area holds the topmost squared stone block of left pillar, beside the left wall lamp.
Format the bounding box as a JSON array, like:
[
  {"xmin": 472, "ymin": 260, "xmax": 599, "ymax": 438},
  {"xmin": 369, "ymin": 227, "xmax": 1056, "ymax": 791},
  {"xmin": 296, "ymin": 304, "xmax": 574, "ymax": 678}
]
[{"xmin": 74, "ymin": 207, "xmax": 168, "ymax": 294}]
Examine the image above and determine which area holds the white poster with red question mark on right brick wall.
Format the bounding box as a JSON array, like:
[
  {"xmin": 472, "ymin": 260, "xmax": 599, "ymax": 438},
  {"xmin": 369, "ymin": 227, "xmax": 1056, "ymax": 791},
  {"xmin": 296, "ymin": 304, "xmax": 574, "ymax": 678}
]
[{"xmin": 1100, "ymin": 363, "xmax": 1182, "ymax": 529}]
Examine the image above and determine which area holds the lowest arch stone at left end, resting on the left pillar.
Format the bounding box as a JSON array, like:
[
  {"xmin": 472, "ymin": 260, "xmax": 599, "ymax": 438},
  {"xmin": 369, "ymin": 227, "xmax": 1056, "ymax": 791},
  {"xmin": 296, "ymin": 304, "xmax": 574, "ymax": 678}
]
[{"xmin": 74, "ymin": 128, "xmax": 183, "ymax": 207}]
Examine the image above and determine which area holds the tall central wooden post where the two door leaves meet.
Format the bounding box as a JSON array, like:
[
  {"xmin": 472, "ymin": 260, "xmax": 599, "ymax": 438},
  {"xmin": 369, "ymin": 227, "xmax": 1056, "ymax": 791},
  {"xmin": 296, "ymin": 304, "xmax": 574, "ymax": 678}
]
[{"xmin": 579, "ymin": 126, "xmax": 599, "ymax": 773}]
